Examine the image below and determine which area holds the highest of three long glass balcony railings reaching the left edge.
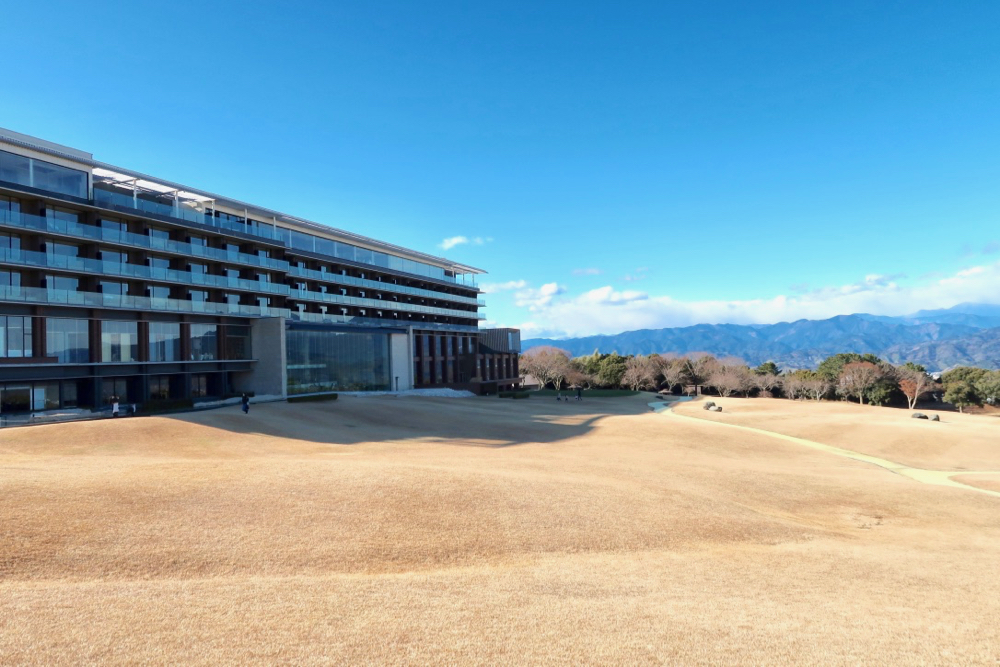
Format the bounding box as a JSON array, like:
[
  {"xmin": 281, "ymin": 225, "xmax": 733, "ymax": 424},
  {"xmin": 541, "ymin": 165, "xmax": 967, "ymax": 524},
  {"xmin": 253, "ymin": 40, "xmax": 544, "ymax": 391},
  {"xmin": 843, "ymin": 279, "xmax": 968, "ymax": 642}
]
[{"xmin": 0, "ymin": 211, "xmax": 288, "ymax": 271}]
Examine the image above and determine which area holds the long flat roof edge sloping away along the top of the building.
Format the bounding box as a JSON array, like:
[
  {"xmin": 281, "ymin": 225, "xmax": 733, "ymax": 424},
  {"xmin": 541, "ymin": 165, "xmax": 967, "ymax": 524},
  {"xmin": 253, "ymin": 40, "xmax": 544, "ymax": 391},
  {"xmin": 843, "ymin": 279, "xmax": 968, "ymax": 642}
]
[{"xmin": 0, "ymin": 127, "xmax": 486, "ymax": 273}]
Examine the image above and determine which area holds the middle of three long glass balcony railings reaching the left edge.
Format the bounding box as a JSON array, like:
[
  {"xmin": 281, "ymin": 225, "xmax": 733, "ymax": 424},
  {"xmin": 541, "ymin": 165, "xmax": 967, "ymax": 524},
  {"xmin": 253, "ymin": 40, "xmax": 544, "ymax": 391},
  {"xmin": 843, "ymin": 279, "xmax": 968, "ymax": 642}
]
[{"xmin": 0, "ymin": 248, "xmax": 289, "ymax": 295}]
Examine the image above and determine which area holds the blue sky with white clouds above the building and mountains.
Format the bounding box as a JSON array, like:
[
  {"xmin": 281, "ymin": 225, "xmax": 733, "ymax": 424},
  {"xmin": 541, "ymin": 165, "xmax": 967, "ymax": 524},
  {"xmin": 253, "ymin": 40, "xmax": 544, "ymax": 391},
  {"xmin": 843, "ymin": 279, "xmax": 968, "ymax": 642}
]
[{"xmin": 0, "ymin": 0, "xmax": 1000, "ymax": 337}]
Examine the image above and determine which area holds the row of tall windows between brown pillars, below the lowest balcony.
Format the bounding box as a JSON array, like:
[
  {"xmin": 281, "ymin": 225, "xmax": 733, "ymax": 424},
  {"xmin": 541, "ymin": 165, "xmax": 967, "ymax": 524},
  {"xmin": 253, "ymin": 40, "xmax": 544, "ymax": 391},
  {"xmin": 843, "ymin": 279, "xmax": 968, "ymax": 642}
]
[{"xmin": 0, "ymin": 315, "xmax": 251, "ymax": 364}]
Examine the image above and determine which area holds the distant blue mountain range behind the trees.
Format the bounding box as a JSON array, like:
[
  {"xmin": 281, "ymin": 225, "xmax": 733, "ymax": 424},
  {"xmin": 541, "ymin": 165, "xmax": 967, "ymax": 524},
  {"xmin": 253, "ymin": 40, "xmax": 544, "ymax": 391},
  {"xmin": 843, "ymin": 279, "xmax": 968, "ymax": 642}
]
[{"xmin": 522, "ymin": 303, "xmax": 1000, "ymax": 371}]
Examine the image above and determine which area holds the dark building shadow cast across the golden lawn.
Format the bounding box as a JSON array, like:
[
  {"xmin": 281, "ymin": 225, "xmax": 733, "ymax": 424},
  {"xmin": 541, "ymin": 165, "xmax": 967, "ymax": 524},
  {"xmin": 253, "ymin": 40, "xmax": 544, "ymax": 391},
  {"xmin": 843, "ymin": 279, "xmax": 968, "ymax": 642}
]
[{"xmin": 166, "ymin": 395, "xmax": 649, "ymax": 448}]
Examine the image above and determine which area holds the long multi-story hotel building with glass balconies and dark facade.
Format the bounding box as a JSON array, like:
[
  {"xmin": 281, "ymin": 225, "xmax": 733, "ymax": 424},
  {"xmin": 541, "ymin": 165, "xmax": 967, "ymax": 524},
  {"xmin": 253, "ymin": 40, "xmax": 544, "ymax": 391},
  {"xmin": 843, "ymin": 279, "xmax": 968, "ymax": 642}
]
[{"xmin": 0, "ymin": 129, "xmax": 520, "ymax": 414}]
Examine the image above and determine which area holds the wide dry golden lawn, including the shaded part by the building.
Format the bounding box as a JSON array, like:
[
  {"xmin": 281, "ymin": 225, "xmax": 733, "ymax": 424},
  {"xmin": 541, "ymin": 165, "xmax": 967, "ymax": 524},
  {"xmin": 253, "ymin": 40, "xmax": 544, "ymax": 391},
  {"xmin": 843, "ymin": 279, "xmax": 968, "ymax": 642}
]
[{"xmin": 0, "ymin": 396, "xmax": 1000, "ymax": 665}]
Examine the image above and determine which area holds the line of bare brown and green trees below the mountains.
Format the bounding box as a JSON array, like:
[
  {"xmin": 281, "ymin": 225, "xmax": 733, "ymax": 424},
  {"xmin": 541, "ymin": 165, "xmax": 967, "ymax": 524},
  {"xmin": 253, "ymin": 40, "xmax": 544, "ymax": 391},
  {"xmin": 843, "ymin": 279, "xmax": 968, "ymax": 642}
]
[{"xmin": 520, "ymin": 346, "xmax": 1000, "ymax": 412}]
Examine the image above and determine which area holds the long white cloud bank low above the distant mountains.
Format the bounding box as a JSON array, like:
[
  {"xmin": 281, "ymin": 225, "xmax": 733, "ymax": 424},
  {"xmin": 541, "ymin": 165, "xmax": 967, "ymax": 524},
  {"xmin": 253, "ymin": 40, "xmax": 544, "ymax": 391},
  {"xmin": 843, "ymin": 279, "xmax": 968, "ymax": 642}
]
[{"xmin": 518, "ymin": 262, "xmax": 1000, "ymax": 338}]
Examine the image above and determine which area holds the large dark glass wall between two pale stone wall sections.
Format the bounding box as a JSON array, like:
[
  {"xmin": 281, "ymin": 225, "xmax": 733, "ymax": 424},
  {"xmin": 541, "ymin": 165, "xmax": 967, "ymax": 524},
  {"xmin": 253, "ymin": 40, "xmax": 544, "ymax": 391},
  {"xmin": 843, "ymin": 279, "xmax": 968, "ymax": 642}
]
[{"xmin": 285, "ymin": 330, "xmax": 391, "ymax": 394}]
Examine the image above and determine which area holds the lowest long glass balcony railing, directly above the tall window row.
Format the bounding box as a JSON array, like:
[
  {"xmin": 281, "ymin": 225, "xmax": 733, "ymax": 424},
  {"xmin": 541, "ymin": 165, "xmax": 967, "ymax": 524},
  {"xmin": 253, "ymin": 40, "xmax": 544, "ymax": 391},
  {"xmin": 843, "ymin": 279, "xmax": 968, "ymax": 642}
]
[{"xmin": 0, "ymin": 285, "xmax": 289, "ymax": 317}]
